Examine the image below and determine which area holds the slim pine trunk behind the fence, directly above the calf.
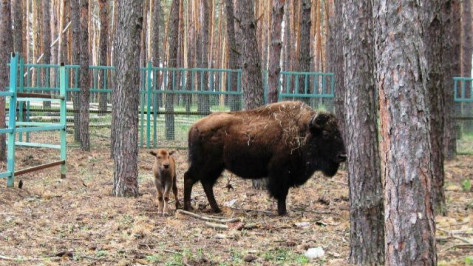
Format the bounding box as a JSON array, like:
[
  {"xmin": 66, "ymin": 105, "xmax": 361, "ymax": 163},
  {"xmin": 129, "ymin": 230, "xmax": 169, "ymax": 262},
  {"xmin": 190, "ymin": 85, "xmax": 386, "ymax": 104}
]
[{"xmin": 164, "ymin": 0, "xmax": 180, "ymax": 140}]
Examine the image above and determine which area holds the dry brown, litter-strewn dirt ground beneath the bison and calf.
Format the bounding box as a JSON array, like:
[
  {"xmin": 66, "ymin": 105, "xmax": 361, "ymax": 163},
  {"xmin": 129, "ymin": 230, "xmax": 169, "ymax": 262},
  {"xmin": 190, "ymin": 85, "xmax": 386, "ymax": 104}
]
[{"xmin": 0, "ymin": 141, "xmax": 473, "ymax": 265}]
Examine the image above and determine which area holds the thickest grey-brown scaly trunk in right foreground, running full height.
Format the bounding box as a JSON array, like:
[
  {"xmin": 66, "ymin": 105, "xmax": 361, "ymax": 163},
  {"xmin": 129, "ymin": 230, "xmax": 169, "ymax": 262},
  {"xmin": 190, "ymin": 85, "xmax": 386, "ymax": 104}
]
[{"xmin": 373, "ymin": 0, "xmax": 437, "ymax": 265}]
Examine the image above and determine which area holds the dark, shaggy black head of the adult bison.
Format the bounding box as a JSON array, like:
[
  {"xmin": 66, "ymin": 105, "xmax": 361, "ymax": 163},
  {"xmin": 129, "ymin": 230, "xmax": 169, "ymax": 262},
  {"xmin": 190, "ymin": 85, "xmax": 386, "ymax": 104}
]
[{"xmin": 306, "ymin": 113, "xmax": 347, "ymax": 176}]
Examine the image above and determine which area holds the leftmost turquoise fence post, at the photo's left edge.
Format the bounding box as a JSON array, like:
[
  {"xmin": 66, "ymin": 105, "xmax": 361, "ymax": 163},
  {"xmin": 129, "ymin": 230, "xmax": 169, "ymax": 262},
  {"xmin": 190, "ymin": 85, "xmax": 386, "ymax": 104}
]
[{"xmin": 7, "ymin": 53, "xmax": 18, "ymax": 187}]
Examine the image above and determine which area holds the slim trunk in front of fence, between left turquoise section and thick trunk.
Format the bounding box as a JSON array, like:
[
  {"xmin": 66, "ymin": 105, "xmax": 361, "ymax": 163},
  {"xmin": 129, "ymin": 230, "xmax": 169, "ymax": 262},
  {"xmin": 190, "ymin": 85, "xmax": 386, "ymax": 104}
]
[{"xmin": 79, "ymin": 0, "xmax": 90, "ymax": 151}]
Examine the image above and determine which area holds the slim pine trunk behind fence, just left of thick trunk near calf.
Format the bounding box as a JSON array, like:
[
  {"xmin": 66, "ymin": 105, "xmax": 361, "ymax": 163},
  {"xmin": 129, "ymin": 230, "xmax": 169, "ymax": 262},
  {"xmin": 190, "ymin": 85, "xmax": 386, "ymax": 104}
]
[{"xmin": 99, "ymin": 0, "xmax": 108, "ymax": 113}]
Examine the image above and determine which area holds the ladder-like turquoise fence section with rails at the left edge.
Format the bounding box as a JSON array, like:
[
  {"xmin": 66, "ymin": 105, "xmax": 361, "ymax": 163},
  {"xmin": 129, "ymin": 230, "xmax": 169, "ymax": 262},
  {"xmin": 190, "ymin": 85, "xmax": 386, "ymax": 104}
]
[{"xmin": 0, "ymin": 55, "xmax": 67, "ymax": 187}]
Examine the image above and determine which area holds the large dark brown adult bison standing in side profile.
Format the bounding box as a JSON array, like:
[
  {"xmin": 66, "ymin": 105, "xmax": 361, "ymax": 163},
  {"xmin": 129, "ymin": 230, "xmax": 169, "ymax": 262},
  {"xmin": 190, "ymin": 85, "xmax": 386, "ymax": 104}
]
[{"xmin": 184, "ymin": 102, "xmax": 346, "ymax": 215}]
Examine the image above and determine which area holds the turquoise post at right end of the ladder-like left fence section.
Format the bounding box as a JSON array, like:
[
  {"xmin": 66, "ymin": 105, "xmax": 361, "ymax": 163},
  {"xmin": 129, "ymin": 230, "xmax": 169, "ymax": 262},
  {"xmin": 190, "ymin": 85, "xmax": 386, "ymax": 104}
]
[{"xmin": 59, "ymin": 63, "xmax": 67, "ymax": 178}]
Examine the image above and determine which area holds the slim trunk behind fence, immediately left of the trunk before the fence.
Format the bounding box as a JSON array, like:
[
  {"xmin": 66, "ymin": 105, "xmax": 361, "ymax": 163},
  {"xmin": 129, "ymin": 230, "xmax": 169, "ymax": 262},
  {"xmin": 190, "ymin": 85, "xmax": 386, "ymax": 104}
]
[{"xmin": 71, "ymin": 0, "xmax": 80, "ymax": 142}]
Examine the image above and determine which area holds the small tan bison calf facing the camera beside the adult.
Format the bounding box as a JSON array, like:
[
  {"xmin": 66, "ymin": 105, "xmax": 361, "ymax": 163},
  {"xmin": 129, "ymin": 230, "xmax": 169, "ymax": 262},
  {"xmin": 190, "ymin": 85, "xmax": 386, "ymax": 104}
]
[{"xmin": 149, "ymin": 149, "xmax": 180, "ymax": 215}]
